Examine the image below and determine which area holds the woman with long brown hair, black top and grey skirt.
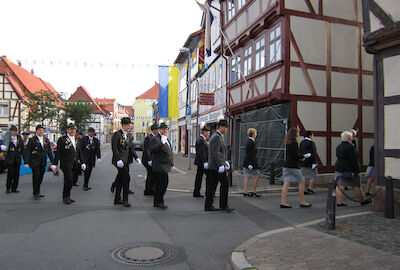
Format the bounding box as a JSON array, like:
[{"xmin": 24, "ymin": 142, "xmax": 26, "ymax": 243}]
[{"xmin": 280, "ymin": 128, "xmax": 311, "ymax": 208}]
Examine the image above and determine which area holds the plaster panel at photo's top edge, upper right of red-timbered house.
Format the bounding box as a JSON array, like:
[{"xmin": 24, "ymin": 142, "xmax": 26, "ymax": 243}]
[{"xmin": 324, "ymin": 0, "xmax": 354, "ymax": 20}]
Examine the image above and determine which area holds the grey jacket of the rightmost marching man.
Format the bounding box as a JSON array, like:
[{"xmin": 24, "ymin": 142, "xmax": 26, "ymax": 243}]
[{"xmin": 208, "ymin": 131, "xmax": 226, "ymax": 171}]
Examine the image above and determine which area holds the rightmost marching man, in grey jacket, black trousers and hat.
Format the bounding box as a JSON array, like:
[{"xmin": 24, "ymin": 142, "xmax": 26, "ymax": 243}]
[{"xmin": 205, "ymin": 119, "xmax": 234, "ymax": 212}]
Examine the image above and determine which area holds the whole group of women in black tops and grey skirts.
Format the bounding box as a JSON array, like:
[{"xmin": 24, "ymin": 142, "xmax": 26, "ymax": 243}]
[{"xmin": 242, "ymin": 128, "xmax": 374, "ymax": 208}]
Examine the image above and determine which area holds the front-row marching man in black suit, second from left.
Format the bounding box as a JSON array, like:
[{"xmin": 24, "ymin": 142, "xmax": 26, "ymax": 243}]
[{"xmin": 24, "ymin": 125, "xmax": 56, "ymax": 200}]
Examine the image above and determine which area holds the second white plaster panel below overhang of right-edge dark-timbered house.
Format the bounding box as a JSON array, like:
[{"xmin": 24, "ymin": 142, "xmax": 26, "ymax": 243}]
[{"xmin": 384, "ymin": 104, "xmax": 400, "ymax": 149}]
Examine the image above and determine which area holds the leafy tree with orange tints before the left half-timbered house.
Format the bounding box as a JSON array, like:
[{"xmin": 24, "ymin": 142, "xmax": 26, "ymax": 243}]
[{"xmin": 24, "ymin": 90, "xmax": 60, "ymax": 129}]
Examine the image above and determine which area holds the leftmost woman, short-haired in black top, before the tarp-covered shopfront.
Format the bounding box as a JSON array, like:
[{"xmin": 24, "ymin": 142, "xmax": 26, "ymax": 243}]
[{"xmin": 243, "ymin": 128, "xmax": 261, "ymax": 197}]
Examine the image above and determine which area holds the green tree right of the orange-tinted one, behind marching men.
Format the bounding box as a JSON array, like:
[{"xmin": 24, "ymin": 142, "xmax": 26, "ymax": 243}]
[{"xmin": 59, "ymin": 99, "xmax": 93, "ymax": 131}]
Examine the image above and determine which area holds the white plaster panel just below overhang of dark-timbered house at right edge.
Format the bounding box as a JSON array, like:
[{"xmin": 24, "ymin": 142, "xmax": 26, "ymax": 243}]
[{"xmin": 383, "ymin": 54, "xmax": 400, "ymax": 97}]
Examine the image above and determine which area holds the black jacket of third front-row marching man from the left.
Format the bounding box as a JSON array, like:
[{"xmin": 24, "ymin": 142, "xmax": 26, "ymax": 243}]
[{"xmin": 53, "ymin": 135, "xmax": 79, "ymax": 170}]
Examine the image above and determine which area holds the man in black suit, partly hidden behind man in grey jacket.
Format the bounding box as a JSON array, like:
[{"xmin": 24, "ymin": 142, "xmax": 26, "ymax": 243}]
[{"xmin": 193, "ymin": 123, "xmax": 210, "ymax": 197}]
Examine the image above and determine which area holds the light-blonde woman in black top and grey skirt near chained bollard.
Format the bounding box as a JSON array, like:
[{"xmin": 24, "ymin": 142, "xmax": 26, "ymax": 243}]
[{"xmin": 335, "ymin": 131, "xmax": 364, "ymax": 206}]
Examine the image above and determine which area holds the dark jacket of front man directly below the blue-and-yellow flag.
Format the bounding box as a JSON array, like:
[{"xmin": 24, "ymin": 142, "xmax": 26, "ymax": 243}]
[{"xmin": 150, "ymin": 133, "xmax": 174, "ymax": 172}]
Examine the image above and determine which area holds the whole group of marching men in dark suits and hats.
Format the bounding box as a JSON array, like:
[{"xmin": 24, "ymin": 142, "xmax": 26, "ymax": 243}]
[{"xmin": 1, "ymin": 117, "xmax": 234, "ymax": 212}]
